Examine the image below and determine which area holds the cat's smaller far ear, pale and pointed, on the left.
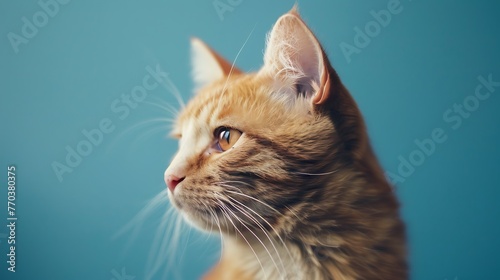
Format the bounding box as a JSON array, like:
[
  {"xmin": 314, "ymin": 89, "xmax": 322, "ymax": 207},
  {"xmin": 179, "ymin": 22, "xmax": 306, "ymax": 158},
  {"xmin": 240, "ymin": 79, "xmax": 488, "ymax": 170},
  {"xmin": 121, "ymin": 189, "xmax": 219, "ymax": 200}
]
[{"xmin": 191, "ymin": 38, "xmax": 241, "ymax": 88}]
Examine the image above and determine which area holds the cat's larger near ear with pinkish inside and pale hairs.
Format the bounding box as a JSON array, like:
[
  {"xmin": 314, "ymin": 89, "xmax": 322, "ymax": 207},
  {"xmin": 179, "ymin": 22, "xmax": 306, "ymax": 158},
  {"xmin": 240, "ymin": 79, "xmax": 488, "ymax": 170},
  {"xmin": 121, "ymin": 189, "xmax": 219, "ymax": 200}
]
[{"xmin": 263, "ymin": 7, "xmax": 330, "ymax": 104}]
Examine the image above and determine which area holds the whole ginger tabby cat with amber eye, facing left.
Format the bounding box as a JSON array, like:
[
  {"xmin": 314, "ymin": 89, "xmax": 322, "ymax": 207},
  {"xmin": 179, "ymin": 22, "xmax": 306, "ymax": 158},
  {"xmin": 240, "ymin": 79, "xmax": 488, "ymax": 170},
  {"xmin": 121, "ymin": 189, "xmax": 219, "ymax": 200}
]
[{"xmin": 164, "ymin": 4, "xmax": 408, "ymax": 280}]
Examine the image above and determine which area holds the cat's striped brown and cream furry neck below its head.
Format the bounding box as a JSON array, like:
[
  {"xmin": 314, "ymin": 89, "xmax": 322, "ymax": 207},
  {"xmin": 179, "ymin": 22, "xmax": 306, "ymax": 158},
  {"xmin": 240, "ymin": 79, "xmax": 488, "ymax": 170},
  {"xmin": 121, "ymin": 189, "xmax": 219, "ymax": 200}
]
[{"xmin": 219, "ymin": 166, "xmax": 407, "ymax": 280}]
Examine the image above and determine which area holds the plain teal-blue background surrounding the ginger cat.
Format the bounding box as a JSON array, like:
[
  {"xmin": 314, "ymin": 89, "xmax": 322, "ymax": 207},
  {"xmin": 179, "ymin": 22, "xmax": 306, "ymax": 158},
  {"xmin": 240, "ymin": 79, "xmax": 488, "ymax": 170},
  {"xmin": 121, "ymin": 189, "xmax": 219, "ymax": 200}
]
[{"xmin": 0, "ymin": 0, "xmax": 500, "ymax": 280}]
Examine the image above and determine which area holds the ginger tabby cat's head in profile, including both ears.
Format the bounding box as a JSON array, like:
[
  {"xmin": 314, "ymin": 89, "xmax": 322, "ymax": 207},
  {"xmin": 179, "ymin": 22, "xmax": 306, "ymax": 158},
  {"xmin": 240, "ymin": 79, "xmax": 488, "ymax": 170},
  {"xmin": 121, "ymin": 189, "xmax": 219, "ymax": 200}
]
[{"xmin": 165, "ymin": 9, "xmax": 364, "ymax": 236}]
